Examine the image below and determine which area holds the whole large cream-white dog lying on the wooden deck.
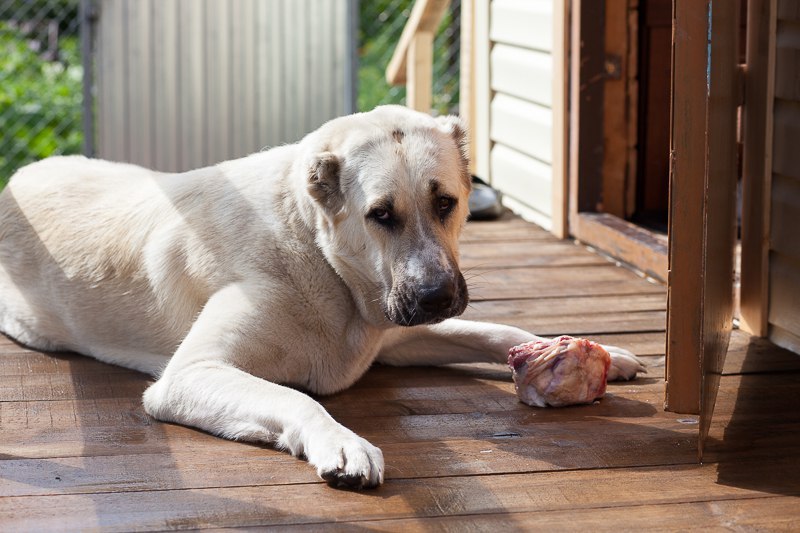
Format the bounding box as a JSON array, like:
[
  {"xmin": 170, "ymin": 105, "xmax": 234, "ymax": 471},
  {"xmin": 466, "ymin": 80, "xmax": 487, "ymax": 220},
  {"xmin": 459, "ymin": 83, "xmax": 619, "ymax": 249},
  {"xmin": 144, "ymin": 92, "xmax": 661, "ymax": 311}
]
[{"xmin": 0, "ymin": 107, "xmax": 642, "ymax": 487}]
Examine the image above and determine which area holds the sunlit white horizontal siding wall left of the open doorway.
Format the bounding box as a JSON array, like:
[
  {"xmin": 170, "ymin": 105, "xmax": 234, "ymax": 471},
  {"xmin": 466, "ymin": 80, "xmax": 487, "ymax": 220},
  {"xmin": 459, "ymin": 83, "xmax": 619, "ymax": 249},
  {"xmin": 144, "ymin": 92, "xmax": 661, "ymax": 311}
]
[{"xmin": 475, "ymin": 0, "xmax": 563, "ymax": 228}]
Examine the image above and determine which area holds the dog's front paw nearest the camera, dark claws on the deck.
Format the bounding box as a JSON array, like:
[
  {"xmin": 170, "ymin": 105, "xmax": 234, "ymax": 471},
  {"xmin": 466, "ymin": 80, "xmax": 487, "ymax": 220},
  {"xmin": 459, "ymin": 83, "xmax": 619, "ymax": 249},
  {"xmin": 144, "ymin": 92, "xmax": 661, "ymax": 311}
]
[{"xmin": 308, "ymin": 428, "xmax": 383, "ymax": 489}]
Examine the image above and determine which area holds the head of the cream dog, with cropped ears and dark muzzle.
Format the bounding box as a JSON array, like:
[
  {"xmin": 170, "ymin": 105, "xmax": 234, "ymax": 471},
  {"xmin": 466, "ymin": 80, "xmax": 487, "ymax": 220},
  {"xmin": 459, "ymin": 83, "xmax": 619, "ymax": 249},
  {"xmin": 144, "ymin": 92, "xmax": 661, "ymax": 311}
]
[{"xmin": 307, "ymin": 106, "xmax": 471, "ymax": 326}]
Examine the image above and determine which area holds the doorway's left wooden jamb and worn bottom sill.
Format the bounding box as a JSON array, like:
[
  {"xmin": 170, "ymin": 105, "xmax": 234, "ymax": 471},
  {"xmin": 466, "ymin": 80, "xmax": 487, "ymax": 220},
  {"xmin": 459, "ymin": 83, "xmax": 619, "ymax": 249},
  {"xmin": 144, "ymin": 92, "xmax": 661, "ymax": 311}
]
[{"xmin": 567, "ymin": 0, "xmax": 668, "ymax": 282}]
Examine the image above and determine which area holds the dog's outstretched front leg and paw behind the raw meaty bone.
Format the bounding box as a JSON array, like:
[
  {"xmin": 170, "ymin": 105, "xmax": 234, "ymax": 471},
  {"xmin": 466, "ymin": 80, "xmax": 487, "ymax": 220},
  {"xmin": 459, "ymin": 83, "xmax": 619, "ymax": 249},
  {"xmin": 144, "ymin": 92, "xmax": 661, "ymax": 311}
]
[{"xmin": 378, "ymin": 318, "xmax": 646, "ymax": 381}]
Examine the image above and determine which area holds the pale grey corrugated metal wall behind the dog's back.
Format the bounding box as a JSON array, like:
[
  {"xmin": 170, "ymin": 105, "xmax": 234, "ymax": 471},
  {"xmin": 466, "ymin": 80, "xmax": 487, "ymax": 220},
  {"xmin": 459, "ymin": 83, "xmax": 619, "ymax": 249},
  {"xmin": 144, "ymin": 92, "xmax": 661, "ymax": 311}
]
[{"xmin": 94, "ymin": 0, "xmax": 356, "ymax": 171}]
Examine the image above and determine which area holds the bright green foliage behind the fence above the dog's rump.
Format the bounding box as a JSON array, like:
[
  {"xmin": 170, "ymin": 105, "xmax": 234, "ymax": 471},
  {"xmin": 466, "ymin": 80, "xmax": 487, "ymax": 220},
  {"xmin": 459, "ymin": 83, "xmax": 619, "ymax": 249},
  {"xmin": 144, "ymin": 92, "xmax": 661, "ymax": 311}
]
[{"xmin": 0, "ymin": 22, "xmax": 83, "ymax": 188}]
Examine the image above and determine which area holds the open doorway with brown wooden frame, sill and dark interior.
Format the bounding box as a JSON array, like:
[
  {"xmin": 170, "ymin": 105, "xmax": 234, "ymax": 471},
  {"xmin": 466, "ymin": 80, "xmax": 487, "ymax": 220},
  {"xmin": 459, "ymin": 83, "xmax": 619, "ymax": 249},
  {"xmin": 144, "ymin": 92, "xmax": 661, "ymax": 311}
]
[{"xmin": 569, "ymin": 0, "xmax": 672, "ymax": 282}]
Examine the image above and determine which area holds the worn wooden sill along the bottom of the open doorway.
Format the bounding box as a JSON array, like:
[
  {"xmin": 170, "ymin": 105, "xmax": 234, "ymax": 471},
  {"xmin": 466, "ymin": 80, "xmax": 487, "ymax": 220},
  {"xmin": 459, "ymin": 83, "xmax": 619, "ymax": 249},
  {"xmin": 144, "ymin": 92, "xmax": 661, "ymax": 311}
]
[{"xmin": 573, "ymin": 213, "xmax": 668, "ymax": 281}]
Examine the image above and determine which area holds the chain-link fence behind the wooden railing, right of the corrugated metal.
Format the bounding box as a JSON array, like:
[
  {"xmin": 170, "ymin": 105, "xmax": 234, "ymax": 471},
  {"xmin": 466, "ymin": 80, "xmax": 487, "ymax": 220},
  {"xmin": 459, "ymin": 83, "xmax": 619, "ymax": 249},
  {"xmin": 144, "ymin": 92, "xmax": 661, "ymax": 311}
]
[{"xmin": 358, "ymin": 0, "xmax": 461, "ymax": 114}]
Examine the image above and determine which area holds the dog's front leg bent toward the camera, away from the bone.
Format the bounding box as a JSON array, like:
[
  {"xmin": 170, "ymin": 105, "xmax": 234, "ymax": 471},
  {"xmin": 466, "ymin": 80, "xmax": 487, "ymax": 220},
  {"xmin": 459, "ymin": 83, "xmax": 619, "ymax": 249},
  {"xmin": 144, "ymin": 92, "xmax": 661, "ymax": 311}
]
[{"xmin": 144, "ymin": 286, "xmax": 383, "ymax": 488}]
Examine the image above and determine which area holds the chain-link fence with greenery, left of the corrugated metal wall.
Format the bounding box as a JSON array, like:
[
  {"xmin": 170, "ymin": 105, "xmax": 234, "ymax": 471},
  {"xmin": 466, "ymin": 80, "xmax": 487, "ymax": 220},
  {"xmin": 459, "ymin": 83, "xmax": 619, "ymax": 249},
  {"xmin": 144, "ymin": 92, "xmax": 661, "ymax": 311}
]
[{"xmin": 0, "ymin": 0, "xmax": 83, "ymax": 188}]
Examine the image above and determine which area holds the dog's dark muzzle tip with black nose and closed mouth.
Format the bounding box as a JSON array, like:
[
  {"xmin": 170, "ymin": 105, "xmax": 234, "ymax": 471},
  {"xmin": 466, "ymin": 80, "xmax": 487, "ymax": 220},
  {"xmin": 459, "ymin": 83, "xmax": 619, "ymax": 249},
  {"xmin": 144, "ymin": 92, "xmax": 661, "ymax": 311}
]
[{"xmin": 384, "ymin": 273, "xmax": 469, "ymax": 327}]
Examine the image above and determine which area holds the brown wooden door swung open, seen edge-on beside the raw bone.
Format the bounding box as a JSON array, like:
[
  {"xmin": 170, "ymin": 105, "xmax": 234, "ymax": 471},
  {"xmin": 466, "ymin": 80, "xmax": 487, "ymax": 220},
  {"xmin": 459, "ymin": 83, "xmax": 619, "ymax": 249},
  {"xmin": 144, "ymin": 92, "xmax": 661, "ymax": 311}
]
[{"xmin": 665, "ymin": 0, "xmax": 739, "ymax": 430}]
